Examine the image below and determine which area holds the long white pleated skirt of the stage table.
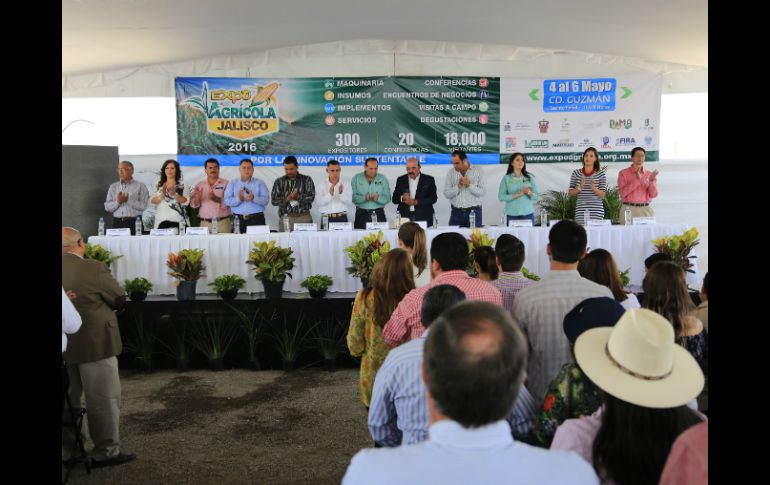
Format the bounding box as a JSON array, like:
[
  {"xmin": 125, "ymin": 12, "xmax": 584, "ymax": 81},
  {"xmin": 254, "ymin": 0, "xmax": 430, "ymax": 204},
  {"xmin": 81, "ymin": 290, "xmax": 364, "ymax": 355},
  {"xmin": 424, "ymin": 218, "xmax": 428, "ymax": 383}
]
[{"xmin": 88, "ymin": 224, "xmax": 701, "ymax": 295}]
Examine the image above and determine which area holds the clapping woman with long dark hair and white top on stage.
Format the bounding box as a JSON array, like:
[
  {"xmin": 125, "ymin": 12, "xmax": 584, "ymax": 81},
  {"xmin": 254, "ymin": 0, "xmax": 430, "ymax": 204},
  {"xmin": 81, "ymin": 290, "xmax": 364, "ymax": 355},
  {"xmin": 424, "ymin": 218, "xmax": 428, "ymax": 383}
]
[{"xmin": 150, "ymin": 160, "xmax": 190, "ymax": 229}]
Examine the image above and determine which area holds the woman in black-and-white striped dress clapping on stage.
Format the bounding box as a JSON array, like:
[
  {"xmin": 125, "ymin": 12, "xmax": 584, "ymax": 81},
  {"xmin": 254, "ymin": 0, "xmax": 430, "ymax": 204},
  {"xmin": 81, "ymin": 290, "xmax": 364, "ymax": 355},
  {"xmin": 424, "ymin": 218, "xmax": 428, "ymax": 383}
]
[{"xmin": 568, "ymin": 147, "xmax": 607, "ymax": 224}]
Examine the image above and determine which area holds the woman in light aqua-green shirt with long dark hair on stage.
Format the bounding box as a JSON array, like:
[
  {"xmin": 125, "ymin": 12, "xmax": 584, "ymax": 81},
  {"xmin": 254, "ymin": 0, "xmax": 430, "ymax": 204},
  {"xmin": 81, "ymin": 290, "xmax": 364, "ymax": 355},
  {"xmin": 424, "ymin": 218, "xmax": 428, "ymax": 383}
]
[{"xmin": 497, "ymin": 153, "xmax": 540, "ymax": 225}]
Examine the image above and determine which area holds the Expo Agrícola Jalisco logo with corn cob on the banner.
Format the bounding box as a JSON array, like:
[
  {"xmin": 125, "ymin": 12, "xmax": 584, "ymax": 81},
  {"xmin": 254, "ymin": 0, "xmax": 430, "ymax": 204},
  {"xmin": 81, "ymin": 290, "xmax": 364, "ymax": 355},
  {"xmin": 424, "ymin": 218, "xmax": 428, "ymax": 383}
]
[{"xmin": 183, "ymin": 82, "xmax": 280, "ymax": 140}]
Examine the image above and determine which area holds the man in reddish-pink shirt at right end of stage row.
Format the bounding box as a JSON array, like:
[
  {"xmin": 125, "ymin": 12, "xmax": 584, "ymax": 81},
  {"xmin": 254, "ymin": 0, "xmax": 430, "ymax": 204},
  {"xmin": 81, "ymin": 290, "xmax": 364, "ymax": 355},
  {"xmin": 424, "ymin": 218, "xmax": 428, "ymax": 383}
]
[{"xmin": 618, "ymin": 147, "xmax": 658, "ymax": 224}]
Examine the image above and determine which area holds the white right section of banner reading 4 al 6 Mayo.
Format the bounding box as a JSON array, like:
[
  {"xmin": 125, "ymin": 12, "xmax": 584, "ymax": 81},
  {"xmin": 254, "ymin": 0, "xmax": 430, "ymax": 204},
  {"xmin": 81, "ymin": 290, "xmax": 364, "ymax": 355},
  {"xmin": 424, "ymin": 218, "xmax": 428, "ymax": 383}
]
[{"xmin": 500, "ymin": 74, "xmax": 662, "ymax": 163}]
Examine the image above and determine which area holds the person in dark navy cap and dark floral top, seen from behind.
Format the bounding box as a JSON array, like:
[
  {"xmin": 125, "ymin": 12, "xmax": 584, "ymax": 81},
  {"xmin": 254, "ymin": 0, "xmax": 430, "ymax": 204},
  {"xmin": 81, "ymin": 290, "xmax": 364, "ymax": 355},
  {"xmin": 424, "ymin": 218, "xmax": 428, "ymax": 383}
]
[{"xmin": 533, "ymin": 297, "xmax": 626, "ymax": 448}]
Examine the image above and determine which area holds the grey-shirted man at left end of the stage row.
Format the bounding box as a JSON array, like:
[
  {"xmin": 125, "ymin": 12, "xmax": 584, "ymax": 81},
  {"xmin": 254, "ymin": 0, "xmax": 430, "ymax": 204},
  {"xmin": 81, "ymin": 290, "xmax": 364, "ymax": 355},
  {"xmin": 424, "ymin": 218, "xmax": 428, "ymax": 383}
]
[{"xmin": 104, "ymin": 161, "xmax": 150, "ymax": 235}]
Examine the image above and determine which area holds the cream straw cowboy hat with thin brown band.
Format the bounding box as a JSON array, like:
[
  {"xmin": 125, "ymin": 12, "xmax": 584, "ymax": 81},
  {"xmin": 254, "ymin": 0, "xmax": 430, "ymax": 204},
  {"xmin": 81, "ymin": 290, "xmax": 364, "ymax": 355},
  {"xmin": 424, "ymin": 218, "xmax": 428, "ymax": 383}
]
[{"xmin": 575, "ymin": 308, "xmax": 704, "ymax": 408}]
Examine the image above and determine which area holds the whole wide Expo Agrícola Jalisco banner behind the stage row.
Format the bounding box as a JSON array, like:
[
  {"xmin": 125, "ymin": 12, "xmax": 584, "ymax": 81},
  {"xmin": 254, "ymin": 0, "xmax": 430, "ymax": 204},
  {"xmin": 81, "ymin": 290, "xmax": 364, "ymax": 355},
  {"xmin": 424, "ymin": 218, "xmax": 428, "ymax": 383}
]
[{"xmin": 176, "ymin": 76, "xmax": 661, "ymax": 166}]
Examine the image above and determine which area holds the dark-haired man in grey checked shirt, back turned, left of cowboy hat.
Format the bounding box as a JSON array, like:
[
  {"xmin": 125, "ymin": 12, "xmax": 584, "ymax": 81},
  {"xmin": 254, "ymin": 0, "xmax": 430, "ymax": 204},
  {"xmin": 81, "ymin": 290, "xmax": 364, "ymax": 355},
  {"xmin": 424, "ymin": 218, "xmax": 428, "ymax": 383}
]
[{"xmin": 513, "ymin": 220, "xmax": 614, "ymax": 399}]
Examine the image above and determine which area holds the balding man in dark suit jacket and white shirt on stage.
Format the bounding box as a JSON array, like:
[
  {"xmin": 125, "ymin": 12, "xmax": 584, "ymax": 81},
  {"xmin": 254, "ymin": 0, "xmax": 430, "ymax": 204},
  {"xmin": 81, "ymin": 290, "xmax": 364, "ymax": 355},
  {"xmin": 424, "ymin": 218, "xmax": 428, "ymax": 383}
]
[{"xmin": 393, "ymin": 157, "xmax": 438, "ymax": 227}]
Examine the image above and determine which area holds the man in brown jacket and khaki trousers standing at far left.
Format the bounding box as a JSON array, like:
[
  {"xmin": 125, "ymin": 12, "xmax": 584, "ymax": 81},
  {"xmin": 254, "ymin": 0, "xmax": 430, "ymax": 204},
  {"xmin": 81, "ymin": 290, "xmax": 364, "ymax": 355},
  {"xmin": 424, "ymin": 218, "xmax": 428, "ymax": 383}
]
[{"xmin": 61, "ymin": 227, "xmax": 136, "ymax": 467}]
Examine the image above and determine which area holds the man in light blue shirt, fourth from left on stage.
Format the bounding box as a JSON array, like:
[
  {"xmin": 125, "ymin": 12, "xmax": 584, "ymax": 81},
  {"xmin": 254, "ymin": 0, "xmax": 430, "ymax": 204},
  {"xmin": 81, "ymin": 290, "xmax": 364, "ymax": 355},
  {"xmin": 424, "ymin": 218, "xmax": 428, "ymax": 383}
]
[{"xmin": 225, "ymin": 158, "xmax": 270, "ymax": 230}]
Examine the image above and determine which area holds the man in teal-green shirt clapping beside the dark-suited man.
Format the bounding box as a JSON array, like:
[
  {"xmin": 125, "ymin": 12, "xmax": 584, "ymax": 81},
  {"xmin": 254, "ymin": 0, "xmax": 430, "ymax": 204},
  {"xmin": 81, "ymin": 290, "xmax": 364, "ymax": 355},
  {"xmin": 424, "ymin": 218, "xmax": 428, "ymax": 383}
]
[{"xmin": 350, "ymin": 157, "xmax": 390, "ymax": 229}]
